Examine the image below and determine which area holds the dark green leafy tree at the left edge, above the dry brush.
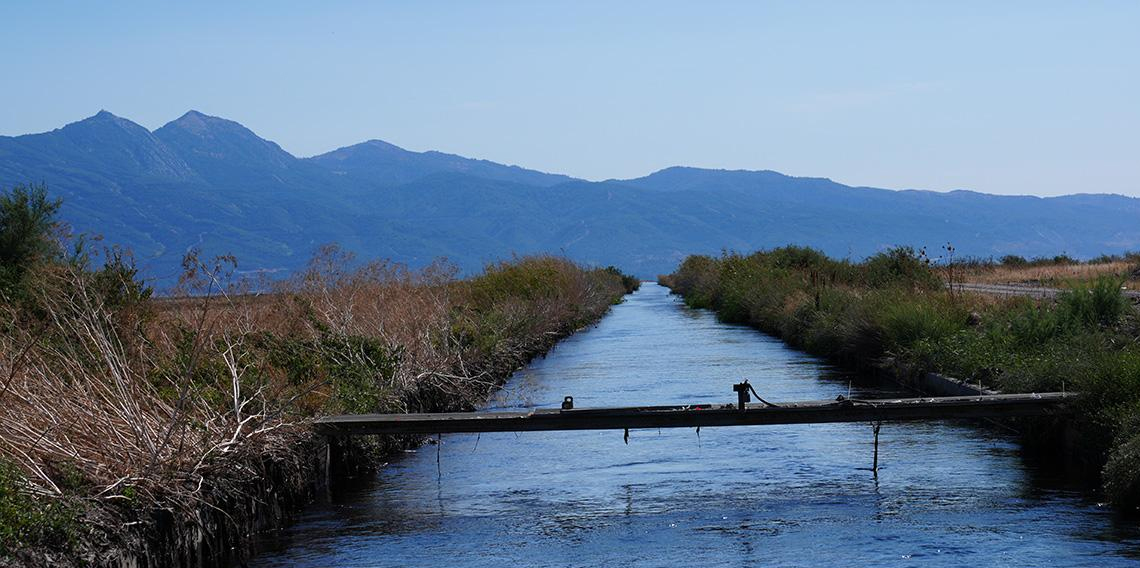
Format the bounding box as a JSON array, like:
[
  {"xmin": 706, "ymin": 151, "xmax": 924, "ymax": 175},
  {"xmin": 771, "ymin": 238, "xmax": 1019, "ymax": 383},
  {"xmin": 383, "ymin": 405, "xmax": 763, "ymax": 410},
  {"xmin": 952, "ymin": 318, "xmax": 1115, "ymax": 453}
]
[{"xmin": 0, "ymin": 184, "xmax": 63, "ymax": 299}]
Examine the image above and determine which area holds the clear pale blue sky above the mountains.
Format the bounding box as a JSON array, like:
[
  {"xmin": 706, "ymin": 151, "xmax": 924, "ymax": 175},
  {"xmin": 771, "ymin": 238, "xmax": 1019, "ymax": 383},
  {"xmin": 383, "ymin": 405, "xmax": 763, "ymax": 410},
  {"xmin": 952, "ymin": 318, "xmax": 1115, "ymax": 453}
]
[{"xmin": 0, "ymin": 0, "xmax": 1140, "ymax": 195}]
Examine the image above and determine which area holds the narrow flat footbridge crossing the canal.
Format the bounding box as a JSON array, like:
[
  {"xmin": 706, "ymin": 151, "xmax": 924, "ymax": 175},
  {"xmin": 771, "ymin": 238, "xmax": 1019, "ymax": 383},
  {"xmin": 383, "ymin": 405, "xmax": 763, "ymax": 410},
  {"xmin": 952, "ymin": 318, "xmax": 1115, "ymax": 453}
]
[{"xmin": 316, "ymin": 383, "xmax": 1076, "ymax": 436}]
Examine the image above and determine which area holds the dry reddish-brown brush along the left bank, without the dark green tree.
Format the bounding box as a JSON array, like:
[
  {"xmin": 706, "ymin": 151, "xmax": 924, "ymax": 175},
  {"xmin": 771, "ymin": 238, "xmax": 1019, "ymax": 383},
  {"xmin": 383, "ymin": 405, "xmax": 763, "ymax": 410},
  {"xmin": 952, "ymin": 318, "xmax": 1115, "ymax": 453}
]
[{"xmin": 0, "ymin": 249, "xmax": 622, "ymax": 558}]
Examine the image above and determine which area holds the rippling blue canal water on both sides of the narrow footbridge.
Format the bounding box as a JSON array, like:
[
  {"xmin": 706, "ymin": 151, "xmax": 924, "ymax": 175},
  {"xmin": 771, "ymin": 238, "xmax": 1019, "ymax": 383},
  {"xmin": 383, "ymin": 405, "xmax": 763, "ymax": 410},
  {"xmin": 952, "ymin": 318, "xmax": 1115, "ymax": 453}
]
[{"xmin": 250, "ymin": 284, "xmax": 1140, "ymax": 568}]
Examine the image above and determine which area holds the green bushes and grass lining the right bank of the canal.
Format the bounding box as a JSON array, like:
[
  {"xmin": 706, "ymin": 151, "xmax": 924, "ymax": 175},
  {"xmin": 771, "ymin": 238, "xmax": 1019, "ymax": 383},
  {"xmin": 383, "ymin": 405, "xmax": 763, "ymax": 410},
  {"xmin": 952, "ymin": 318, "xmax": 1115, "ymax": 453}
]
[{"xmin": 659, "ymin": 246, "xmax": 1140, "ymax": 510}]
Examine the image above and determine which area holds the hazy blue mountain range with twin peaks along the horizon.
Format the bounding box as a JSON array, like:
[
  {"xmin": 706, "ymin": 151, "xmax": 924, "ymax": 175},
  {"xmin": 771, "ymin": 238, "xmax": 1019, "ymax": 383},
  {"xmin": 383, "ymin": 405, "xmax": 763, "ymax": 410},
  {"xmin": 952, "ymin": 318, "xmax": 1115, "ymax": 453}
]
[{"xmin": 0, "ymin": 111, "xmax": 1140, "ymax": 283}]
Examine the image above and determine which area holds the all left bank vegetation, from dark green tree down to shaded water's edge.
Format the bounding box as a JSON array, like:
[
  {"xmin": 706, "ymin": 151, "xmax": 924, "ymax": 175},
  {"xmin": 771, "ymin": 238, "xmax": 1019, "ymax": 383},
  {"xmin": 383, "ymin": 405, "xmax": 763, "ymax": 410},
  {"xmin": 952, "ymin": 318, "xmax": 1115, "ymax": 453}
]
[{"xmin": 0, "ymin": 186, "xmax": 638, "ymax": 566}]
